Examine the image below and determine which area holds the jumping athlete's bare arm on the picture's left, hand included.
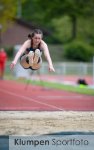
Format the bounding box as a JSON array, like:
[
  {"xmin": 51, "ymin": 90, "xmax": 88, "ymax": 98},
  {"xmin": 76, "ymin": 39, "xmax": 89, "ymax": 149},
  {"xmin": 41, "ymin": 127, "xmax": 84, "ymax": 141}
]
[{"xmin": 10, "ymin": 40, "xmax": 29, "ymax": 69}]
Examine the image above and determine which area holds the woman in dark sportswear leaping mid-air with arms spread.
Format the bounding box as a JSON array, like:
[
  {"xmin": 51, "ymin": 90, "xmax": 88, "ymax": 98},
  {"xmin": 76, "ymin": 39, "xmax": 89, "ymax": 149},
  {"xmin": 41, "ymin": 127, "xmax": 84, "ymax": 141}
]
[{"xmin": 10, "ymin": 29, "xmax": 55, "ymax": 72}]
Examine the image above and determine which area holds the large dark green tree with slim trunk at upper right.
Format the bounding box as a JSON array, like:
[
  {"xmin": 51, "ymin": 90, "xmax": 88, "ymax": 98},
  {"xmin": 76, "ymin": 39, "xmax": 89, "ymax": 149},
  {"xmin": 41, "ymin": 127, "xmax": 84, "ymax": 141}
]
[{"xmin": 36, "ymin": 0, "xmax": 94, "ymax": 39}]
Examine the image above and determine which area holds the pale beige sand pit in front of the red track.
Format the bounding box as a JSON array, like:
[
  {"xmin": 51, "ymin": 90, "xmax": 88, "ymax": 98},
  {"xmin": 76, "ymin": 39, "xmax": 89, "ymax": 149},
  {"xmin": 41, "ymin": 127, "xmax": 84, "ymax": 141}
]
[{"xmin": 0, "ymin": 111, "xmax": 94, "ymax": 135}]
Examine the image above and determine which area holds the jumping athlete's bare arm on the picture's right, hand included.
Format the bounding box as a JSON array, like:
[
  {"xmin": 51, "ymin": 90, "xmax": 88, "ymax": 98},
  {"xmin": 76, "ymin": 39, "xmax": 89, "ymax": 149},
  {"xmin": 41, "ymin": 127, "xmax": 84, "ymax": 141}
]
[{"xmin": 42, "ymin": 41, "xmax": 55, "ymax": 72}]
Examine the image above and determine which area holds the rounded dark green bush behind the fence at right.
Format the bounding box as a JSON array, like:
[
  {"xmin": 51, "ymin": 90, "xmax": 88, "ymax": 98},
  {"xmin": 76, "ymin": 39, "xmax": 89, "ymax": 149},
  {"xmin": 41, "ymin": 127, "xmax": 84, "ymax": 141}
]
[{"xmin": 63, "ymin": 41, "xmax": 94, "ymax": 62}]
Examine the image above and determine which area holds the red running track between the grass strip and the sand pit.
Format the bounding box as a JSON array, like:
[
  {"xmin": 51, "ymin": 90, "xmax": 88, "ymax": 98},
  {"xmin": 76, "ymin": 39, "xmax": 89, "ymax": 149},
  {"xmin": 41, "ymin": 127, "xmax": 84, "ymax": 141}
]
[{"xmin": 0, "ymin": 80, "xmax": 94, "ymax": 111}]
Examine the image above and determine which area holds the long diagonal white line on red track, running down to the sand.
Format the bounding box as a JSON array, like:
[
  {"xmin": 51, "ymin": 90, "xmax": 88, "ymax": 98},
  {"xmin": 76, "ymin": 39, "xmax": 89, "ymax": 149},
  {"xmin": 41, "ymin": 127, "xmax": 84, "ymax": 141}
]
[{"xmin": 0, "ymin": 89, "xmax": 64, "ymax": 111}]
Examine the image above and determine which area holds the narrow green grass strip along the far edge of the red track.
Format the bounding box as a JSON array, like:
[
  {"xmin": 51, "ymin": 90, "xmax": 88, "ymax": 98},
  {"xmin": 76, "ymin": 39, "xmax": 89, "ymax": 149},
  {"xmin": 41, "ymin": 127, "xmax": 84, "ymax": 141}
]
[{"xmin": 5, "ymin": 75, "xmax": 94, "ymax": 96}]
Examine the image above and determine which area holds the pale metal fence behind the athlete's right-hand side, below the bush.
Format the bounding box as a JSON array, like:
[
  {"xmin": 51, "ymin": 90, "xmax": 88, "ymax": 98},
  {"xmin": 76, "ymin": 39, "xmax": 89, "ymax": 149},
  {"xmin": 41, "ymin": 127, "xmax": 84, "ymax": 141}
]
[{"xmin": 40, "ymin": 62, "xmax": 93, "ymax": 76}]
